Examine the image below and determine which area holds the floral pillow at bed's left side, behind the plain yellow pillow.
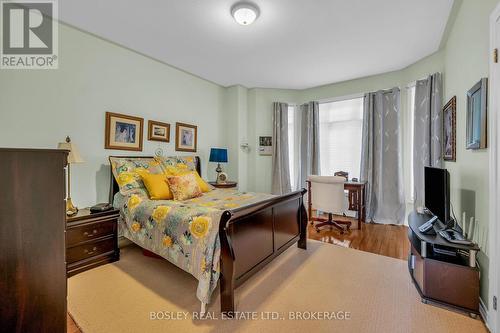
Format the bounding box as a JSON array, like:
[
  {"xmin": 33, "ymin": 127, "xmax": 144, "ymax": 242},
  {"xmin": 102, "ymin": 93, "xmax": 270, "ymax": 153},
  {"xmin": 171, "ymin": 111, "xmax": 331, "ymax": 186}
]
[{"xmin": 109, "ymin": 157, "xmax": 163, "ymax": 195}]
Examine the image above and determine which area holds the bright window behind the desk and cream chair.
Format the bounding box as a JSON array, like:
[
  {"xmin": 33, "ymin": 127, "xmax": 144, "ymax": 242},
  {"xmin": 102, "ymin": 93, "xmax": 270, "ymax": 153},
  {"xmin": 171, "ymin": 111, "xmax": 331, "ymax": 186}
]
[{"xmin": 319, "ymin": 97, "xmax": 363, "ymax": 179}]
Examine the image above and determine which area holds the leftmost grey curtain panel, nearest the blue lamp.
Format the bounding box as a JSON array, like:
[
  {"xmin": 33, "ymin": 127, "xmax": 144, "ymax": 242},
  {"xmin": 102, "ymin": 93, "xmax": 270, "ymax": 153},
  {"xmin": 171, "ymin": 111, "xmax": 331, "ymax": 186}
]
[{"xmin": 271, "ymin": 102, "xmax": 292, "ymax": 194}]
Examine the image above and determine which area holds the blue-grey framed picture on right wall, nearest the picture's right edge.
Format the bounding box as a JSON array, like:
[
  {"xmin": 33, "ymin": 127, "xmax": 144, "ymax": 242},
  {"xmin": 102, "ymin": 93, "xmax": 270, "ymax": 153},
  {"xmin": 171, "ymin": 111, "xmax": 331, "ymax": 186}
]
[{"xmin": 466, "ymin": 78, "xmax": 488, "ymax": 149}]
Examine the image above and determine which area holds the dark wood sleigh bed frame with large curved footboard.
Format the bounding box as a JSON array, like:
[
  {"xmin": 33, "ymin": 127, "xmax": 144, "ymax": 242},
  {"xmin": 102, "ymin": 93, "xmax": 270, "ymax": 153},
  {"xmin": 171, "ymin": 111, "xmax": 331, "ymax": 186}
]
[{"xmin": 109, "ymin": 156, "xmax": 307, "ymax": 316}]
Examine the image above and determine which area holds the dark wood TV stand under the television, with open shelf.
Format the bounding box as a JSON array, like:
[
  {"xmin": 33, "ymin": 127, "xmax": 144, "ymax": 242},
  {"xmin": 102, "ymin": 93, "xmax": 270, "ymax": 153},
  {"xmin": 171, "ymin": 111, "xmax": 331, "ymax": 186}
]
[{"xmin": 408, "ymin": 212, "xmax": 479, "ymax": 318}]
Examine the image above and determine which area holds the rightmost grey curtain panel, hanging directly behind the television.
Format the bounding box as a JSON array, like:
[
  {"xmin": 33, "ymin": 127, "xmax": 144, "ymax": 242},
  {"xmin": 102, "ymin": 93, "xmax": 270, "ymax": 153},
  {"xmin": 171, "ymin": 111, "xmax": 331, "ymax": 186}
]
[{"xmin": 413, "ymin": 73, "xmax": 443, "ymax": 211}]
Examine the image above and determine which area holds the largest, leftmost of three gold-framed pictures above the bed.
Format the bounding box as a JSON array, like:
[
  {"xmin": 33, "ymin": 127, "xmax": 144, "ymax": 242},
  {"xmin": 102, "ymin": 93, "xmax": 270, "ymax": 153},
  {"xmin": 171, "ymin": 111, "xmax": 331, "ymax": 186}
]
[{"xmin": 104, "ymin": 112, "xmax": 144, "ymax": 151}]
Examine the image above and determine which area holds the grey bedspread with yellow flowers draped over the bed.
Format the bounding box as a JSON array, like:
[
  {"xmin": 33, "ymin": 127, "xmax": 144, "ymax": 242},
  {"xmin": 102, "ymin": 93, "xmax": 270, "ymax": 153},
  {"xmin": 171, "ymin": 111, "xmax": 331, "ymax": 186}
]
[{"xmin": 114, "ymin": 189, "xmax": 273, "ymax": 303}]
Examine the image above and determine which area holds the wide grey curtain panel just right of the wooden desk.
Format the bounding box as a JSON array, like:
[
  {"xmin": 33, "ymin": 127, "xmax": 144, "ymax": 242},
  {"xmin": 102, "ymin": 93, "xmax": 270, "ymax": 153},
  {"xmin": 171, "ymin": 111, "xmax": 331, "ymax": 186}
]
[{"xmin": 360, "ymin": 88, "xmax": 405, "ymax": 224}]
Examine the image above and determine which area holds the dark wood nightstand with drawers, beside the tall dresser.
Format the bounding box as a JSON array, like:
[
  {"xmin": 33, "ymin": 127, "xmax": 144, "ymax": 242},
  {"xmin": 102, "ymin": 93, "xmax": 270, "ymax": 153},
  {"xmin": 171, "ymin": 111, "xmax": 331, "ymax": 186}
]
[{"xmin": 66, "ymin": 208, "xmax": 120, "ymax": 277}]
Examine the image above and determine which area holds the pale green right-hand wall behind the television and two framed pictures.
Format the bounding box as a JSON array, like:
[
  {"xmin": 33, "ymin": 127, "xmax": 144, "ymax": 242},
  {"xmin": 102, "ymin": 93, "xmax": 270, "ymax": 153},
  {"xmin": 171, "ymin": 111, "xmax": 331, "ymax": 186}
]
[{"xmin": 444, "ymin": 0, "xmax": 499, "ymax": 306}]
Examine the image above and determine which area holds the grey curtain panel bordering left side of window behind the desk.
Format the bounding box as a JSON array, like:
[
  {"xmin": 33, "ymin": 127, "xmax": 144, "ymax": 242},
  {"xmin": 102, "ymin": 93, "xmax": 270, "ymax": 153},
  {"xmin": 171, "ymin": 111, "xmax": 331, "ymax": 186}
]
[{"xmin": 296, "ymin": 102, "xmax": 320, "ymax": 189}]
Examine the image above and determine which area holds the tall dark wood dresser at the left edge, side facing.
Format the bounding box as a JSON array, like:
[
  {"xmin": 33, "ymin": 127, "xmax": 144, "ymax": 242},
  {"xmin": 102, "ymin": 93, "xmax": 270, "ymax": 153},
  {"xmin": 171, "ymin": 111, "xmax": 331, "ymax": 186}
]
[{"xmin": 0, "ymin": 148, "xmax": 67, "ymax": 333}]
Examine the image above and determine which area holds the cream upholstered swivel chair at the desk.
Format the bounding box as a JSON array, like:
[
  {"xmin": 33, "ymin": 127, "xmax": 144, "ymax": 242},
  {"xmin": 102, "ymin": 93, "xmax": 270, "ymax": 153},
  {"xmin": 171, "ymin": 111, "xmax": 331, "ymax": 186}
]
[{"xmin": 307, "ymin": 176, "xmax": 351, "ymax": 234}]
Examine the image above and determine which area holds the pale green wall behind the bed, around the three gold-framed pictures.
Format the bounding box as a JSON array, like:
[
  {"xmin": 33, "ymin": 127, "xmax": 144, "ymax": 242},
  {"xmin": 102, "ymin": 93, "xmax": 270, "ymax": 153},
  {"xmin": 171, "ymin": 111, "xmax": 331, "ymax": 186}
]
[{"xmin": 0, "ymin": 24, "xmax": 226, "ymax": 207}]
